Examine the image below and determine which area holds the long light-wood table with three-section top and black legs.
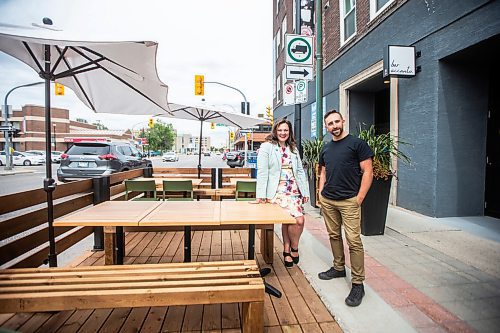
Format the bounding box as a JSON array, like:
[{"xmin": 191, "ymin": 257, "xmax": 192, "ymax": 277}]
[{"xmin": 54, "ymin": 201, "xmax": 295, "ymax": 264}]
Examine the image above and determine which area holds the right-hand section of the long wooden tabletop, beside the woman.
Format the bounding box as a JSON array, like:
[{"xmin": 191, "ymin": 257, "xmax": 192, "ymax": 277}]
[{"xmin": 220, "ymin": 201, "xmax": 295, "ymax": 225}]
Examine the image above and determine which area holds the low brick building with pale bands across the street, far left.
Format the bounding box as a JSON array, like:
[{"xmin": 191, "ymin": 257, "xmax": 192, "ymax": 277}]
[{"xmin": 0, "ymin": 105, "xmax": 131, "ymax": 151}]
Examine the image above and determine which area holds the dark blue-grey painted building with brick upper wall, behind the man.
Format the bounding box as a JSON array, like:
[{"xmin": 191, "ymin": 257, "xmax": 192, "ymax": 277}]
[{"xmin": 273, "ymin": 0, "xmax": 500, "ymax": 217}]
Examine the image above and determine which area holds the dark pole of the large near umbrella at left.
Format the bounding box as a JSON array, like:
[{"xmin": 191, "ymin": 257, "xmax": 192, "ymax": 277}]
[{"xmin": 43, "ymin": 45, "xmax": 57, "ymax": 267}]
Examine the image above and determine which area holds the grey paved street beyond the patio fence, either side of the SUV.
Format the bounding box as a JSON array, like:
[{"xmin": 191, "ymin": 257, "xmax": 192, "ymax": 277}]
[{"xmin": 0, "ymin": 154, "xmax": 228, "ymax": 195}]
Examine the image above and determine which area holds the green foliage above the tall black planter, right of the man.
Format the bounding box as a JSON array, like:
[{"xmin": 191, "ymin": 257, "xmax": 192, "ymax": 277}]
[{"xmin": 358, "ymin": 125, "xmax": 411, "ymax": 180}]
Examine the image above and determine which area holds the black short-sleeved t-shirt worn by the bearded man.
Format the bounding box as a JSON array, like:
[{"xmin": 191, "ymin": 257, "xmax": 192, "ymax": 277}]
[{"xmin": 319, "ymin": 134, "xmax": 373, "ymax": 200}]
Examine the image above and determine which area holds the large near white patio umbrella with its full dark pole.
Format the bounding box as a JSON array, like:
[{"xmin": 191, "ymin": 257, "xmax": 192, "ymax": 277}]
[{"xmin": 0, "ymin": 18, "xmax": 172, "ymax": 267}]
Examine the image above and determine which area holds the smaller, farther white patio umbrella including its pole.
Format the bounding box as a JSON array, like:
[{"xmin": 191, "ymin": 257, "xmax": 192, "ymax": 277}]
[{"xmin": 160, "ymin": 103, "xmax": 265, "ymax": 178}]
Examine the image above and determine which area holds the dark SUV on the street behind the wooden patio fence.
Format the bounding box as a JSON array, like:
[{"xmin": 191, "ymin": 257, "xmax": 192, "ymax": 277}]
[{"xmin": 57, "ymin": 142, "xmax": 153, "ymax": 182}]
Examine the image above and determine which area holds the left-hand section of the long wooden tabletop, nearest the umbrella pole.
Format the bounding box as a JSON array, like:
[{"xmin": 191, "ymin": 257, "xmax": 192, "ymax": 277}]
[{"xmin": 54, "ymin": 201, "xmax": 161, "ymax": 227}]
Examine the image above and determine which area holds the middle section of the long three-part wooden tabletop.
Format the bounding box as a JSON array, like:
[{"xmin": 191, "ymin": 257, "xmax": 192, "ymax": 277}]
[{"xmin": 139, "ymin": 201, "xmax": 220, "ymax": 226}]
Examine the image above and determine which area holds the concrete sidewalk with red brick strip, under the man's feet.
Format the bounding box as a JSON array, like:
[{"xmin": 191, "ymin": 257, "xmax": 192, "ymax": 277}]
[{"xmin": 292, "ymin": 206, "xmax": 500, "ymax": 332}]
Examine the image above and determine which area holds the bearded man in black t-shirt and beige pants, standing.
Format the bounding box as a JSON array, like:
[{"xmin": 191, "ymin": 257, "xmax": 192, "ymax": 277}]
[{"xmin": 318, "ymin": 110, "xmax": 373, "ymax": 306}]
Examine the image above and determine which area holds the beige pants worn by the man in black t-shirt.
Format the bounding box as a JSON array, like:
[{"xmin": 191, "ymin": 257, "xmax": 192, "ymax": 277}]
[{"xmin": 320, "ymin": 196, "xmax": 365, "ymax": 284}]
